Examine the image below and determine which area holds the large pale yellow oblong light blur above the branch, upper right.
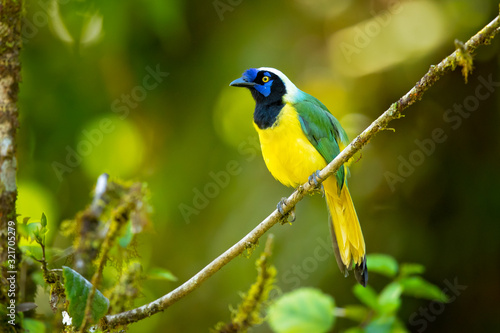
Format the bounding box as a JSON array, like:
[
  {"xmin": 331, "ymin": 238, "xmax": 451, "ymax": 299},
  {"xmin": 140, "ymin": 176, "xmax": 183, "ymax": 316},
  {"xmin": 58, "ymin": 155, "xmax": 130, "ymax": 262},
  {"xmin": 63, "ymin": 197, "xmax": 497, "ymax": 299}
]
[{"xmin": 329, "ymin": 1, "xmax": 448, "ymax": 77}]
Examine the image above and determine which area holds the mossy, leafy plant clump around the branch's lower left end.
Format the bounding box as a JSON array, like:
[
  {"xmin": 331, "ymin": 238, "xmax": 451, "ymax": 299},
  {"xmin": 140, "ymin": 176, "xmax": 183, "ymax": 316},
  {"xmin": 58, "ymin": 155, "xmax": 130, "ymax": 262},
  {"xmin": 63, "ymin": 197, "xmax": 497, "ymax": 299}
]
[{"xmin": 15, "ymin": 174, "xmax": 177, "ymax": 332}]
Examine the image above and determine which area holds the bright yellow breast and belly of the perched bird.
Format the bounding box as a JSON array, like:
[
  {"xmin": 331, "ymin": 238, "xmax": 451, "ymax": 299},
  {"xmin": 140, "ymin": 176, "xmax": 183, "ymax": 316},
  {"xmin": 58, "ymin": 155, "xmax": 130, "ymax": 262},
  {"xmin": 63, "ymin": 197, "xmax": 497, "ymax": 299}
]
[{"xmin": 254, "ymin": 104, "xmax": 326, "ymax": 187}]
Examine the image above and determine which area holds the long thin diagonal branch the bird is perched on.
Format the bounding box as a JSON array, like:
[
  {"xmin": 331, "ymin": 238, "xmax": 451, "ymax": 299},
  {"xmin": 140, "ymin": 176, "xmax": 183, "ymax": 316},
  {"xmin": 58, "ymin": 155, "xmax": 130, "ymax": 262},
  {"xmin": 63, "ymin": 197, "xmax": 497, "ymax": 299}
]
[{"xmin": 103, "ymin": 11, "xmax": 500, "ymax": 328}]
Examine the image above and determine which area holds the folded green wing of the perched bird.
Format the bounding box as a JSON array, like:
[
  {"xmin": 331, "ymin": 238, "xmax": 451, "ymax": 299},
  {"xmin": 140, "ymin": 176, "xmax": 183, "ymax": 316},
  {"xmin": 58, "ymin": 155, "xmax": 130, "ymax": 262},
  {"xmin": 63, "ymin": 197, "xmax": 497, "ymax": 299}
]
[{"xmin": 293, "ymin": 92, "xmax": 348, "ymax": 190}]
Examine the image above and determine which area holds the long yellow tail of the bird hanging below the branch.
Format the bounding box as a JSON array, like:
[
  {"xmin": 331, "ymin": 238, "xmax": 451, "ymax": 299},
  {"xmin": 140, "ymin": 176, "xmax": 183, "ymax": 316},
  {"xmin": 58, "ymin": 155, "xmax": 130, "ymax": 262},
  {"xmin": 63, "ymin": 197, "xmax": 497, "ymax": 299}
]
[{"xmin": 323, "ymin": 177, "xmax": 368, "ymax": 285}]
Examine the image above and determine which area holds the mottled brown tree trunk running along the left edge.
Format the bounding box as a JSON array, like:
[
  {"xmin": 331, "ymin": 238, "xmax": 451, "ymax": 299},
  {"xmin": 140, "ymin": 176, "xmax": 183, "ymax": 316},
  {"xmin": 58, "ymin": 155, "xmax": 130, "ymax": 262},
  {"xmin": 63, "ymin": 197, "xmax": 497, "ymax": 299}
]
[{"xmin": 0, "ymin": 0, "xmax": 23, "ymax": 332}]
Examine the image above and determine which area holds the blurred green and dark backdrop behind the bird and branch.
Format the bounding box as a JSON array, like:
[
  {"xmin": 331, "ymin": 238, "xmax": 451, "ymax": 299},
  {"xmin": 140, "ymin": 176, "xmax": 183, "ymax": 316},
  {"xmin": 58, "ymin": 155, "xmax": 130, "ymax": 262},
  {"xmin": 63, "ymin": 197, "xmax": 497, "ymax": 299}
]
[{"xmin": 18, "ymin": 0, "xmax": 500, "ymax": 332}]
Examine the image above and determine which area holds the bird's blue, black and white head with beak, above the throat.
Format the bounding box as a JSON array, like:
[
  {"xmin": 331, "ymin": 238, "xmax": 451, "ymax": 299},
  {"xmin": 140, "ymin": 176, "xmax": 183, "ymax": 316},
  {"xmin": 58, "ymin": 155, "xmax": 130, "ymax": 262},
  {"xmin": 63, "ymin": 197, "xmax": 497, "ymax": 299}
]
[{"xmin": 229, "ymin": 67, "xmax": 298, "ymax": 103}]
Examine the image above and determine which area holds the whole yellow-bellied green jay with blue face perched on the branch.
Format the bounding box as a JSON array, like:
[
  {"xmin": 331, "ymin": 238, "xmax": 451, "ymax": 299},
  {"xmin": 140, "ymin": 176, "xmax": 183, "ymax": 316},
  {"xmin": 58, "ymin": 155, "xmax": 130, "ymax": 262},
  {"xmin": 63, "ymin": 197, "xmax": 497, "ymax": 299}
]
[{"xmin": 230, "ymin": 67, "xmax": 368, "ymax": 286}]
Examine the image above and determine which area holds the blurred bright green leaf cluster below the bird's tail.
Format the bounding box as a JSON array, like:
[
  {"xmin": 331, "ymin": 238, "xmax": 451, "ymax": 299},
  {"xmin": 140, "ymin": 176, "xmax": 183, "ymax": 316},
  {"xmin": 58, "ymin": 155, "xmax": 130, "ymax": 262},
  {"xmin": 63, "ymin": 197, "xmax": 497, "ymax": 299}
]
[{"xmin": 268, "ymin": 254, "xmax": 448, "ymax": 333}]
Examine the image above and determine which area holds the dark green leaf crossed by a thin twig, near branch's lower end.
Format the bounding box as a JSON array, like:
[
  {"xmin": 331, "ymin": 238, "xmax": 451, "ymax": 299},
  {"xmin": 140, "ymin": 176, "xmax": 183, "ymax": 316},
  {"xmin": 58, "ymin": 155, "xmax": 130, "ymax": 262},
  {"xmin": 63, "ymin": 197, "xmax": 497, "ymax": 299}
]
[{"xmin": 63, "ymin": 266, "xmax": 109, "ymax": 328}]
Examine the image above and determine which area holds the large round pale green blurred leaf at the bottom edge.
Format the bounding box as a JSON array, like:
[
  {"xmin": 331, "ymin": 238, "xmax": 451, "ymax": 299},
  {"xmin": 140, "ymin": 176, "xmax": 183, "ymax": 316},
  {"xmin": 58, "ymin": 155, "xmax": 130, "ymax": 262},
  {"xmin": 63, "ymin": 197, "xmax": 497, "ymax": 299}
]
[{"xmin": 268, "ymin": 288, "xmax": 335, "ymax": 333}]
